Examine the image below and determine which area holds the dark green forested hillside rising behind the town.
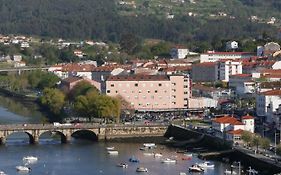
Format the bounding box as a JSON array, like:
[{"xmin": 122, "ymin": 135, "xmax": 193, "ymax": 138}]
[{"xmin": 0, "ymin": 0, "xmax": 281, "ymax": 43}]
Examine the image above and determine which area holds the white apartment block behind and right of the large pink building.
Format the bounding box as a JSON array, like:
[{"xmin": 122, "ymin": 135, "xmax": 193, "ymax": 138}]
[{"xmin": 217, "ymin": 60, "xmax": 242, "ymax": 82}]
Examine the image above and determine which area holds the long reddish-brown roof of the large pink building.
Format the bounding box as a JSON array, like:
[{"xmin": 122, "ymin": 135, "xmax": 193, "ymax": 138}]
[{"xmin": 107, "ymin": 74, "xmax": 170, "ymax": 81}]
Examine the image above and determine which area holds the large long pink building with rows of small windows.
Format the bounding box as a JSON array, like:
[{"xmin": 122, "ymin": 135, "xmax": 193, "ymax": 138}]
[{"xmin": 106, "ymin": 75, "xmax": 191, "ymax": 111}]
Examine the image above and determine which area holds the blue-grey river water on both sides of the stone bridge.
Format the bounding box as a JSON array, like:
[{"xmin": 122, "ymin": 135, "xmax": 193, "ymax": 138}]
[{"xmin": 0, "ymin": 96, "xmax": 230, "ymax": 175}]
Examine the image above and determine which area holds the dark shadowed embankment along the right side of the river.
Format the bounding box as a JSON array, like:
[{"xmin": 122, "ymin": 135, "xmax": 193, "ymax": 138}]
[{"xmin": 165, "ymin": 125, "xmax": 281, "ymax": 175}]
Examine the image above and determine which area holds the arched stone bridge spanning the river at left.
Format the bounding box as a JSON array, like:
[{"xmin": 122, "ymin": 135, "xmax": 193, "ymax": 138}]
[{"xmin": 0, "ymin": 123, "xmax": 168, "ymax": 144}]
